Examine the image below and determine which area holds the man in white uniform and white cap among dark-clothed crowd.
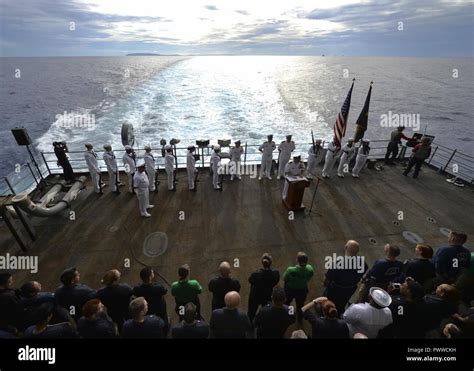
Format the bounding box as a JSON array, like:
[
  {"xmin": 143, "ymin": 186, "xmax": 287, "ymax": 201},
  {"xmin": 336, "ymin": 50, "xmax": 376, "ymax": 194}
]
[{"xmin": 343, "ymin": 287, "xmax": 393, "ymax": 339}]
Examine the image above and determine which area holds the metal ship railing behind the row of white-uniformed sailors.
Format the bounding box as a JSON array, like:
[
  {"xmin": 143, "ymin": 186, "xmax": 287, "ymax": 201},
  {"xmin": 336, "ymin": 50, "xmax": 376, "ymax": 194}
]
[{"xmin": 0, "ymin": 140, "xmax": 474, "ymax": 195}]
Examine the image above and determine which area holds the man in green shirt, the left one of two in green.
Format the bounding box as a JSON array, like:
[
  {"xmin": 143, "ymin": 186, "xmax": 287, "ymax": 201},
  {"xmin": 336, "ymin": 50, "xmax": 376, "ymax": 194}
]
[{"xmin": 171, "ymin": 264, "xmax": 202, "ymax": 321}]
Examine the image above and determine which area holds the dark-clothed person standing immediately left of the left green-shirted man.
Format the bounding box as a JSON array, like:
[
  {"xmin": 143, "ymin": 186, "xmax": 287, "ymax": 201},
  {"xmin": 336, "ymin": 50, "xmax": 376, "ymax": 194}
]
[{"xmin": 133, "ymin": 267, "xmax": 168, "ymax": 323}]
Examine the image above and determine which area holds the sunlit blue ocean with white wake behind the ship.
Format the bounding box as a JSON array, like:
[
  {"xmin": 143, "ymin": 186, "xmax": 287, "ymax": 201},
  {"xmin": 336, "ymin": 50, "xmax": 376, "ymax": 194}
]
[{"xmin": 0, "ymin": 56, "xmax": 474, "ymax": 176}]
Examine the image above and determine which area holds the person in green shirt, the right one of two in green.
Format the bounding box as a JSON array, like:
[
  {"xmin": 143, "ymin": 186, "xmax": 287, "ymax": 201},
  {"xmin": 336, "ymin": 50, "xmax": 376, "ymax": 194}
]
[{"xmin": 283, "ymin": 252, "xmax": 314, "ymax": 322}]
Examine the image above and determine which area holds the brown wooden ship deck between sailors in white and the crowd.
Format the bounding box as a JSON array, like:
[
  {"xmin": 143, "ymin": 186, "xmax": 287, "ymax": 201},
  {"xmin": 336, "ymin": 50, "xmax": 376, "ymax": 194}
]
[{"xmin": 0, "ymin": 165, "xmax": 474, "ymax": 321}]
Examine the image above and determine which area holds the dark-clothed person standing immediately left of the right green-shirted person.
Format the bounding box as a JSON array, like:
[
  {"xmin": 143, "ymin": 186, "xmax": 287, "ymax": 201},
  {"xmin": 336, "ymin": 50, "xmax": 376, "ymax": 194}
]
[{"xmin": 247, "ymin": 253, "xmax": 280, "ymax": 322}]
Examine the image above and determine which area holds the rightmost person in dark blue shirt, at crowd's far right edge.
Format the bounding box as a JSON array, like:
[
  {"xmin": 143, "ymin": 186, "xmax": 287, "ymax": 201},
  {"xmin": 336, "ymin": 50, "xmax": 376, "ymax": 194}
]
[{"xmin": 433, "ymin": 231, "xmax": 471, "ymax": 283}]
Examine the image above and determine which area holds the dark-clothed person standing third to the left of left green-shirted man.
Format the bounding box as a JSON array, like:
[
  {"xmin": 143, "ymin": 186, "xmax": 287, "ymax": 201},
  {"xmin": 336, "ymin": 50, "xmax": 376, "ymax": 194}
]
[{"xmin": 54, "ymin": 267, "xmax": 97, "ymax": 321}]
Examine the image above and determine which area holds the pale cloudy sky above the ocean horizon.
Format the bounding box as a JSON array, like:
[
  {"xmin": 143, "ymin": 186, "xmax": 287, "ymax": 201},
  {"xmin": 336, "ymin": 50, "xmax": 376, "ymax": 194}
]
[{"xmin": 0, "ymin": 0, "xmax": 474, "ymax": 57}]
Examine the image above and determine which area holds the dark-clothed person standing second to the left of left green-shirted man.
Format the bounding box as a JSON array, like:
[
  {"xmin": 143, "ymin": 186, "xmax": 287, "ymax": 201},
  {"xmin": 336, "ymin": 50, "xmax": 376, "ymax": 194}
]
[{"xmin": 97, "ymin": 269, "xmax": 133, "ymax": 330}]
